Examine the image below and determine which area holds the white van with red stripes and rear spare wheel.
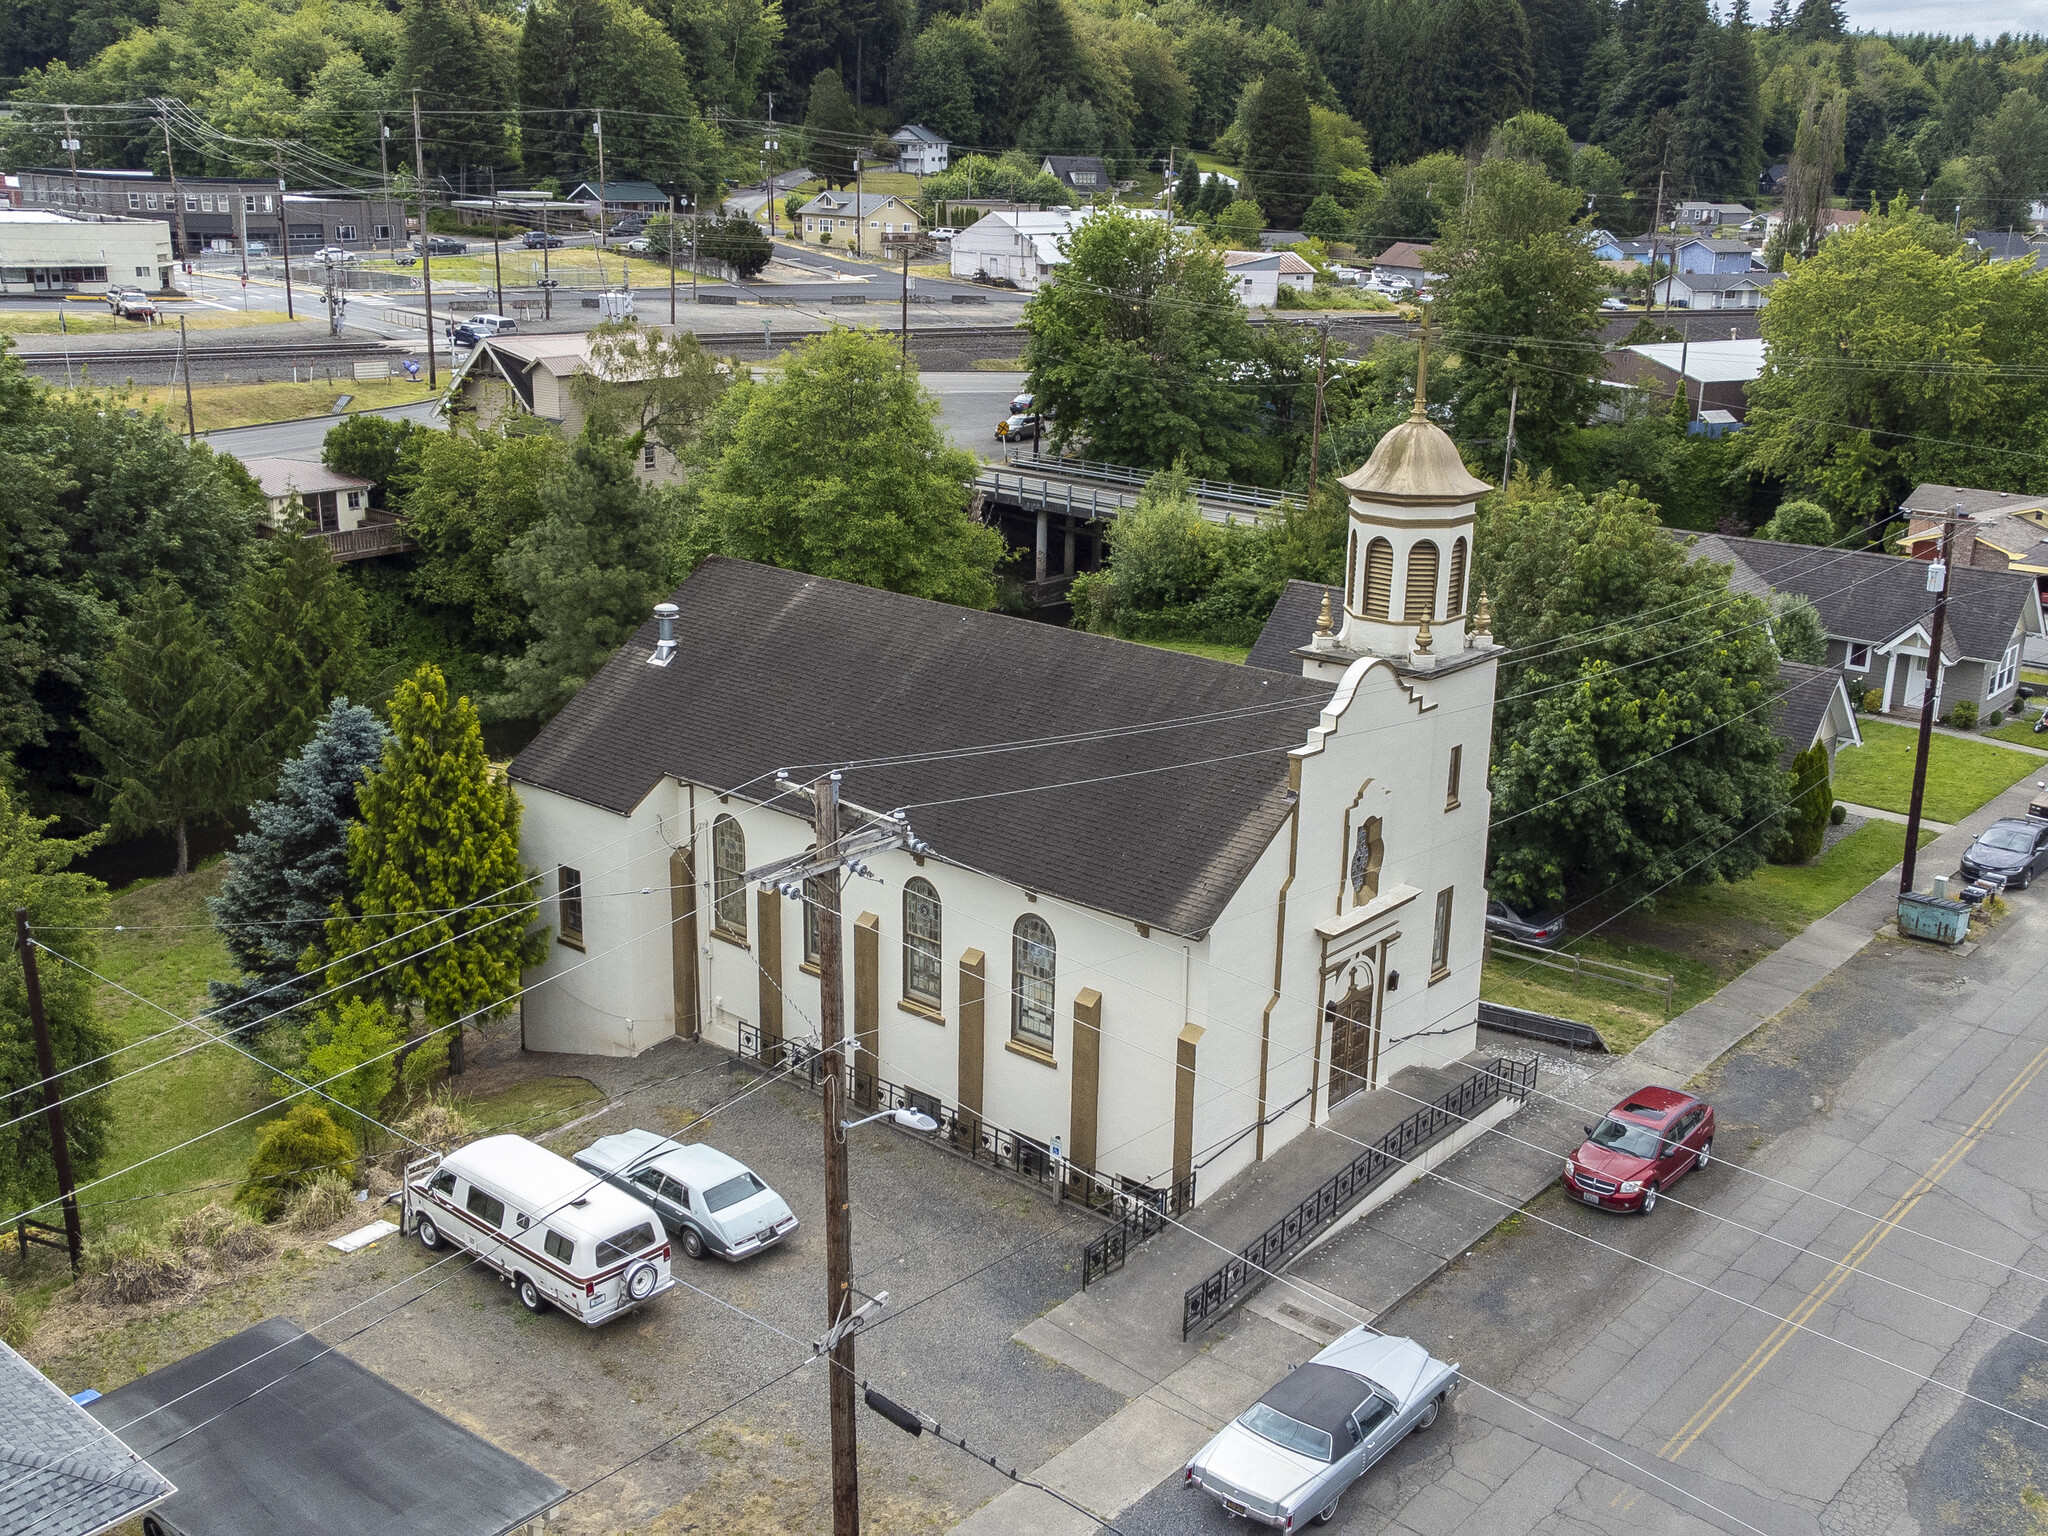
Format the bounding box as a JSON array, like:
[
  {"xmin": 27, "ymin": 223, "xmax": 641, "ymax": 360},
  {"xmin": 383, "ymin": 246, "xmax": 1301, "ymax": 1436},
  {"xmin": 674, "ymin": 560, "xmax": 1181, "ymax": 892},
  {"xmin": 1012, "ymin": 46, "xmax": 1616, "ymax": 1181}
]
[{"xmin": 401, "ymin": 1137, "xmax": 676, "ymax": 1327}]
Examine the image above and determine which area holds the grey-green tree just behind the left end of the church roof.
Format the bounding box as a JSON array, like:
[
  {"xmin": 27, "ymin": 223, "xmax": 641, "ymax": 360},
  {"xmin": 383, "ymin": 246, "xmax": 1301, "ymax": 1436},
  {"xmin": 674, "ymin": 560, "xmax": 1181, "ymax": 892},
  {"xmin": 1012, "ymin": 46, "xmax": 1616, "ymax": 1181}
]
[{"xmin": 496, "ymin": 432, "xmax": 666, "ymax": 719}]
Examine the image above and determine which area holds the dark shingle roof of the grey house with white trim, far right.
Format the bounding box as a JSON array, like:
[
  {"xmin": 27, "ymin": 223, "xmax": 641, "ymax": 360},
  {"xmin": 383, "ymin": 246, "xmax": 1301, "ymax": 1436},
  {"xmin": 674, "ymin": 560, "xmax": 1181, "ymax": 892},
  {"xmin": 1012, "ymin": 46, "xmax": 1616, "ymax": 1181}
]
[{"xmin": 1692, "ymin": 535, "xmax": 2034, "ymax": 662}]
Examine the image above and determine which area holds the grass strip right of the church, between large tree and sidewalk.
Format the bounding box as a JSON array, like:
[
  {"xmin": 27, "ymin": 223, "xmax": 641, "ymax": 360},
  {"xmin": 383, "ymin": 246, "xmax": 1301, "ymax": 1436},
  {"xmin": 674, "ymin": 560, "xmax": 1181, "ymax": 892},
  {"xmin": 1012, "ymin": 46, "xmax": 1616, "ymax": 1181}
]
[{"xmin": 1479, "ymin": 819, "xmax": 1935, "ymax": 1053}]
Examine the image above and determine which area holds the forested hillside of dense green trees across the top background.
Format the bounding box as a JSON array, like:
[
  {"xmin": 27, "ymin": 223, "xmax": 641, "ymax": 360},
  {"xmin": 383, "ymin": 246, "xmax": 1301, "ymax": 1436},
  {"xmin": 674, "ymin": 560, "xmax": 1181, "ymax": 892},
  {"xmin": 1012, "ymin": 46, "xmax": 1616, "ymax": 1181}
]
[{"xmin": 0, "ymin": 0, "xmax": 2048, "ymax": 238}]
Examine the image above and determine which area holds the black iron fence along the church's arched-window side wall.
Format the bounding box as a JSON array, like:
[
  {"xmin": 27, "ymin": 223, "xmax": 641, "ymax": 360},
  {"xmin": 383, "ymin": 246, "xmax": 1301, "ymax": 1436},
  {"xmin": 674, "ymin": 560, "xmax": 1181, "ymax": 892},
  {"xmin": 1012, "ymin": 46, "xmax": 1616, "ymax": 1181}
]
[{"xmin": 735, "ymin": 1024, "xmax": 1194, "ymax": 1236}]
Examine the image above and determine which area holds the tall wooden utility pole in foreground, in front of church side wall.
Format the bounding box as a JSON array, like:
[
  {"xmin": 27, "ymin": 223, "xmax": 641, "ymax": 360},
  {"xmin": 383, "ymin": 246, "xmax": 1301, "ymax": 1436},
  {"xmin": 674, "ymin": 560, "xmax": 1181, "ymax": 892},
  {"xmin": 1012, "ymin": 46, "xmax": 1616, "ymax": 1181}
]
[{"xmin": 809, "ymin": 772, "xmax": 860, "ymax": 1536}]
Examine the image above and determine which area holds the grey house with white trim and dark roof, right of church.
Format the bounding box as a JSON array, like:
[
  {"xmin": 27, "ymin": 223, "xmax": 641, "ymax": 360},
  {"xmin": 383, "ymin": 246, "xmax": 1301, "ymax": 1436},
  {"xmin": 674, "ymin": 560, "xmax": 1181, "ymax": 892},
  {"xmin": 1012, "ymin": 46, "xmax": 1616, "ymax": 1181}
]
[{"xmin": 1690, "ymin": 535, "xmax": 2044, "ymax": 715}]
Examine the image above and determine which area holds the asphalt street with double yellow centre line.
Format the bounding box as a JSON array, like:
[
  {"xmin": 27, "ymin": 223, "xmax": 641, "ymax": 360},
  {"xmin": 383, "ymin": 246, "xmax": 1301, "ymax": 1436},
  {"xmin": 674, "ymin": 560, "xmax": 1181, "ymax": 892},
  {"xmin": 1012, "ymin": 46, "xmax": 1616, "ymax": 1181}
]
[{"xmin": 1116, "ymin": 895, "xmax": 2048, "ymax": 1536}]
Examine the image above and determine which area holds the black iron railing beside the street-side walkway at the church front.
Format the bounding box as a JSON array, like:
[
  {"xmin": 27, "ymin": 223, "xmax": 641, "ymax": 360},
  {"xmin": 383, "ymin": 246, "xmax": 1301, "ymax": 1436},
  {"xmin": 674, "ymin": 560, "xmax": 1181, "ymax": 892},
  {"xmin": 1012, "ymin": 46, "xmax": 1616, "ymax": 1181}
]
[{"xmin": 1180, "ymin": 1057, "xmax": 1536, "ymax": 1339}]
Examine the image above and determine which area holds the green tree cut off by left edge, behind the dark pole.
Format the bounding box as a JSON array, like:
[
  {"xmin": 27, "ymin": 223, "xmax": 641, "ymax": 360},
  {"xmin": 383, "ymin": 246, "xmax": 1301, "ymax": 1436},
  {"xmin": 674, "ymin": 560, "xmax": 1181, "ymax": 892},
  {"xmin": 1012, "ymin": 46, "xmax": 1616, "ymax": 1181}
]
[{"xmin": 0, "ymin": 776, "xmax": 115, "ymax": 1221}]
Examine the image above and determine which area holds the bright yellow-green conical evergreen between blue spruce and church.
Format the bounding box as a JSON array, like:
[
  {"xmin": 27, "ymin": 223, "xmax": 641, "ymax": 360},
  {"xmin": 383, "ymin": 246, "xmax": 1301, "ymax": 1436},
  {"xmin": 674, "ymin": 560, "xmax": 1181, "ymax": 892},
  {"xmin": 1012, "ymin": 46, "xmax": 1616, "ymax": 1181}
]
[{"xmin": 326, "ymin": 664, "xmax": 547, "ymax": 1075}]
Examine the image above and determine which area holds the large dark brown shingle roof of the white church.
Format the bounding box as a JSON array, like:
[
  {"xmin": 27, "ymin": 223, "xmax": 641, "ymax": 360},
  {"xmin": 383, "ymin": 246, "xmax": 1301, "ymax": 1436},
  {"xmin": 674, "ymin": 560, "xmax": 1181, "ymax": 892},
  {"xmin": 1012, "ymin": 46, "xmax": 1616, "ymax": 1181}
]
[{"xmin": 512, "ymin": 557, "xmax": 1331, "ymax": 936}]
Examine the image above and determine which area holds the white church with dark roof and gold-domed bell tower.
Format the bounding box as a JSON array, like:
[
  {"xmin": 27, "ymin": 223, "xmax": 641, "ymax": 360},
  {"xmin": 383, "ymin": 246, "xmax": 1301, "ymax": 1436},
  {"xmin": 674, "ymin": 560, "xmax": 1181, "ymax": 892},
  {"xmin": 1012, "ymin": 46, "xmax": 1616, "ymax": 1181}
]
[{"xmin": 510, "ymin": 382, "xmax": 1499, "ymax": 1198}]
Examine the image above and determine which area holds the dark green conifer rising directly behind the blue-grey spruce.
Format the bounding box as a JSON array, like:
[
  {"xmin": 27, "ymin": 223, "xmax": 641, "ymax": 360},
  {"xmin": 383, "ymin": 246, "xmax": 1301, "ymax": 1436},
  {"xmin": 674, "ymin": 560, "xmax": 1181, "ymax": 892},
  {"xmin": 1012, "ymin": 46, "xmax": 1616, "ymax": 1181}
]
[{"xmin": 233, "ymin": 532, "xmax": 369, "ymax": 774}]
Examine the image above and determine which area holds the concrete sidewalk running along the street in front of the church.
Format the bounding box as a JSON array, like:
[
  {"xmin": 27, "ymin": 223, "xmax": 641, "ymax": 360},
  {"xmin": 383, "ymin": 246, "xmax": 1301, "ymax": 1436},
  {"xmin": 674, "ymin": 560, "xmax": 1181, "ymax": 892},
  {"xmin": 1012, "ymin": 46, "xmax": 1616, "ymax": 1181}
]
[{"xmin": 956, "ymin": 780, "xmax": 2032, "ymax": 1536}]
